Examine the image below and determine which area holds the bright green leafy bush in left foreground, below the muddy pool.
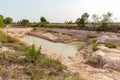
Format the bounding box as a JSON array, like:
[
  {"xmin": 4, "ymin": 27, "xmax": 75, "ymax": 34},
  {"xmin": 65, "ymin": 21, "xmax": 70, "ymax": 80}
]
[{"xmin": 26, "ymin": 44, "xmax": 41, "ymax": 59}]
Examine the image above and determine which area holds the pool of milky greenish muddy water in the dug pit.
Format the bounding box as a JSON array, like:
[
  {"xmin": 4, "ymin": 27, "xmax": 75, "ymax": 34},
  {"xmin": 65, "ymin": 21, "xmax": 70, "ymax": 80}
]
[{"xmin": 22, "ymin": 35, "xmax": 83, "ymax": 56}]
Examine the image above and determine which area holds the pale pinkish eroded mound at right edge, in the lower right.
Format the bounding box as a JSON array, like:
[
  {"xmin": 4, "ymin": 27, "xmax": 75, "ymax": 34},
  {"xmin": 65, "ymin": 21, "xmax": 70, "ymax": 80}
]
[{"xmin": 89, "ymin": 46, "xmax": 120, "ymax": 71}]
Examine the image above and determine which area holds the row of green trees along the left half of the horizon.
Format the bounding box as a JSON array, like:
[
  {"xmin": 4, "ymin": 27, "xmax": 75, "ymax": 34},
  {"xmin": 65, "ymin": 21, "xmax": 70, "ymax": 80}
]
[{"xmin": 0, "ymin": 15, "xmax": 49, "ymax": 28}]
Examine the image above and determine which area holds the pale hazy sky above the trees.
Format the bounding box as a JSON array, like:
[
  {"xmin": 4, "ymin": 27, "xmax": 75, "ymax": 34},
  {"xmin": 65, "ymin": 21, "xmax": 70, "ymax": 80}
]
[{"xmin": 0, "ymin": 0, "xmax": 120, "ymax": 23}]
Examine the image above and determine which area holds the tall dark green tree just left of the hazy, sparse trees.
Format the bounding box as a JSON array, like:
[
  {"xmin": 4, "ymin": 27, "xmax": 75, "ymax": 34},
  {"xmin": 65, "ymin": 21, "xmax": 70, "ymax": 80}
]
[{"xmin": 76, "ymin": 13, "xmax": 89, "ymax": 27}]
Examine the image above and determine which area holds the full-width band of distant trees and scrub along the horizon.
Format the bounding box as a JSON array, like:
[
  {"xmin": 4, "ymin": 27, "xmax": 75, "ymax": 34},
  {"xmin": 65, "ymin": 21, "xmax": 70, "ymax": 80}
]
[{"xmin": 0, "ymin": 12, "xmax": 120, "ymax": 31}]
